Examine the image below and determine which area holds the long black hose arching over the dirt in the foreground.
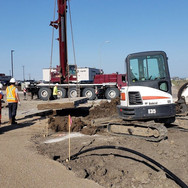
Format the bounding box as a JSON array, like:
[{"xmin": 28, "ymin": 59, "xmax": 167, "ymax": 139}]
[{"xmin": 70, "ymin": 146, "xmax": 188, "ymax": 188}]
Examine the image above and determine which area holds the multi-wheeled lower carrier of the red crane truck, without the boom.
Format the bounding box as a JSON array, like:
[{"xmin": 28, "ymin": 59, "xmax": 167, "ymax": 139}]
[{"xmin": 27, "ymin": 73, "xmax": 126, "ymax": 100}]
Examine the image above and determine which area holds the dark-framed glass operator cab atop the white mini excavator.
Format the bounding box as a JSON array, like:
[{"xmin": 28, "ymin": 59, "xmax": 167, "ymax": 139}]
[{"xmin": 126, "ymin": 51, "xmax": 172, "ymax": 94}]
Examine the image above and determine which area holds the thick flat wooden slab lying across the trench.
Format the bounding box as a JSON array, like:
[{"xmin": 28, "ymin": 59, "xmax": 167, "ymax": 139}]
[{"xmin": 37, "ymin": 97, "xmax": 88, "ymax": 110}]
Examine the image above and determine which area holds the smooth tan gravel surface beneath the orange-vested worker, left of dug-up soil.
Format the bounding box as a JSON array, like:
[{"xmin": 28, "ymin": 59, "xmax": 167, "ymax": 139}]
[{"xmin": 0, "ymin": 93, "xmax": 101, "ymax": 188}]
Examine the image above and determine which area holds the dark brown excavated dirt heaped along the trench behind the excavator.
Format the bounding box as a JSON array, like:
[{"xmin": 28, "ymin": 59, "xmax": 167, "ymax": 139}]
[{"xmin": 48, "ymin": 98, "xmax": 119, "ymax": 135}]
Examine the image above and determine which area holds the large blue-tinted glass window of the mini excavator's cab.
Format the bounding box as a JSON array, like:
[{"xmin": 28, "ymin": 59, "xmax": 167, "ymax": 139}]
[{"xmin": 130, "ymin": 55, "xmax": 167, "ymax": 82}]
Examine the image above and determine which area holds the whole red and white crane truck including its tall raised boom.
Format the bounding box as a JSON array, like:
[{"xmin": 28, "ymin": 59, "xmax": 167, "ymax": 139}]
[{"xmin": 27, "ymin": 0, "xmax": 126, "ymax": 100}]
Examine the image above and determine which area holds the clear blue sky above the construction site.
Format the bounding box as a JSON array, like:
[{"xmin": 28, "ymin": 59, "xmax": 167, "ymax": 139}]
[{"xmin": 0, "ymin": 0, "xmax": 188, "ymax": 79}]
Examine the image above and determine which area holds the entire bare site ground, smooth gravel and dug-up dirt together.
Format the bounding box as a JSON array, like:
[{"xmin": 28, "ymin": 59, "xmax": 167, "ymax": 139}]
[{"xmin": 0, "ymin": 87, "xmax": 188, "ymax": 188}]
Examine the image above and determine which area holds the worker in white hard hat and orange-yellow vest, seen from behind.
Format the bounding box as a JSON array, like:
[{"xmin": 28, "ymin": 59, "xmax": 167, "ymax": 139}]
[{"xmin": 6, "ymin": 78, "xmax": 20, "ymax": 125}]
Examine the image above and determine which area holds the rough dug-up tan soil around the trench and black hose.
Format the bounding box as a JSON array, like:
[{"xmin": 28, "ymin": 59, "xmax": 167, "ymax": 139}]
[{"xmin": 0, "ymin": 86, "xmax": 188, "ymax": 188}]
